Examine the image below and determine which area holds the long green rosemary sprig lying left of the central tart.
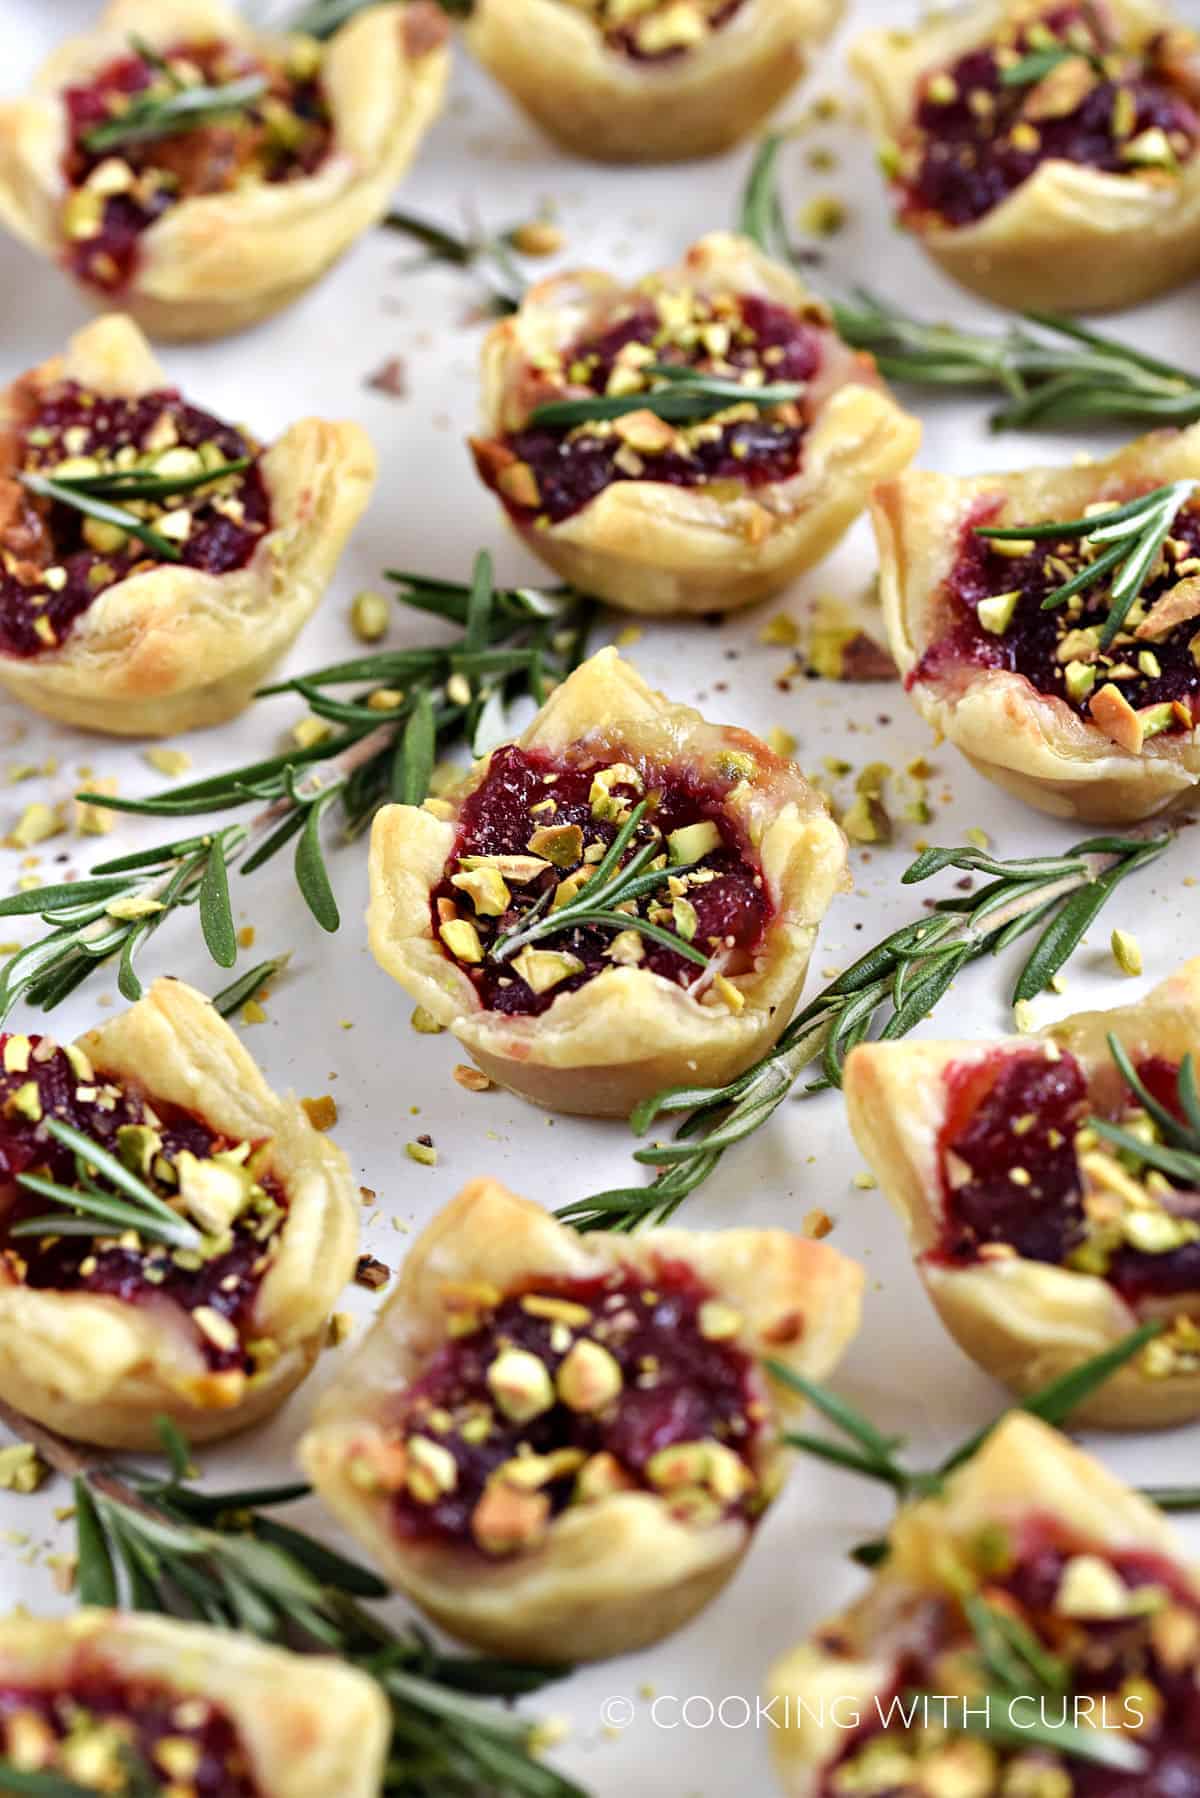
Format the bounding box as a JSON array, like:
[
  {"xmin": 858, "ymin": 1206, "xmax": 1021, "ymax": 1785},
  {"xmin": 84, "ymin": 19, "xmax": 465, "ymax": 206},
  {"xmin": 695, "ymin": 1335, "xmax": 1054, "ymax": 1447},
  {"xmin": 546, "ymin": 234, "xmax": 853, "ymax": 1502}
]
[{"xmin": 0, "ymin": 554, "xmax": 592, "ymax": 1023}]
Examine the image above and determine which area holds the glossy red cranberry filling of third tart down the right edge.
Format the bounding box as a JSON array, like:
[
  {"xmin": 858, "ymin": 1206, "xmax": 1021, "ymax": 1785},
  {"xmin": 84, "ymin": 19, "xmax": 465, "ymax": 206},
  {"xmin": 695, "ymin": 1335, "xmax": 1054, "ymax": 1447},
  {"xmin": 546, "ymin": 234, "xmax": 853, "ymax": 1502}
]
[{"xmin": 934, "ymin": 1048, "xmax": 1200, "ymax": 1304}]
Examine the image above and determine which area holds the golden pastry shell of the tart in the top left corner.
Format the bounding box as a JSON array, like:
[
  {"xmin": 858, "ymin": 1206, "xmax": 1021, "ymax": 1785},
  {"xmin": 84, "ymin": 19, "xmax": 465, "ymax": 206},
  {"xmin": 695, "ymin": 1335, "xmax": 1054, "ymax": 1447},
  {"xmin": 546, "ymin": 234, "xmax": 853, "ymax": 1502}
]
[{"xmin": 0, "ymin": 0, "xmax": 450, "ymax": 342}]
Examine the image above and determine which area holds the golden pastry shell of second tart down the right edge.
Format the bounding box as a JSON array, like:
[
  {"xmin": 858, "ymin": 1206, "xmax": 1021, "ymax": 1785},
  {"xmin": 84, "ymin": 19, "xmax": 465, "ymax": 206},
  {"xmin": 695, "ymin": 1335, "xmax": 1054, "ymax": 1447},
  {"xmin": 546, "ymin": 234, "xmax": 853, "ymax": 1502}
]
[{"xmin": 871, "ymin": 424, "xmax": 1200, "ymax": 823}]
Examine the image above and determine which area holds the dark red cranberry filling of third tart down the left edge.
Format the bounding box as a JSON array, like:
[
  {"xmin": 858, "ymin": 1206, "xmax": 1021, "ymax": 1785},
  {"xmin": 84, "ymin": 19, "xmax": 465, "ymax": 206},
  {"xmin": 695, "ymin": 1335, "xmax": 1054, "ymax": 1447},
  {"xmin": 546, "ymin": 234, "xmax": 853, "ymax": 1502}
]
[{"xmin": 0, "ymin": 1036, "xmax": 286, "ymax": 1372}]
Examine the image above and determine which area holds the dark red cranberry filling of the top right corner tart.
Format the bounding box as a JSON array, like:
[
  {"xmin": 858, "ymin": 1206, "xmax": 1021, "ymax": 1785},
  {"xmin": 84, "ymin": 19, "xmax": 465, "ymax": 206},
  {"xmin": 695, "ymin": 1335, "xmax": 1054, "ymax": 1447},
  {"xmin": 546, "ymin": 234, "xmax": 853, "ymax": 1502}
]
[{"xmin": 905, "ymin": 5, "xmax": 1200, "ymax": 227}]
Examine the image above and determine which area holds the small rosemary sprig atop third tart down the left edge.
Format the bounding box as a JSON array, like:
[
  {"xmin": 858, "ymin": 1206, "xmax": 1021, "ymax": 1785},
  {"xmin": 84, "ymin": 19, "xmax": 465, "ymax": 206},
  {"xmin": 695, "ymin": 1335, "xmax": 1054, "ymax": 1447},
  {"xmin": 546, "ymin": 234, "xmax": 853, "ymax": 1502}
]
[{"xmin": 9, "ymin": 1117, "xmax": 203, "ymax": 1251}]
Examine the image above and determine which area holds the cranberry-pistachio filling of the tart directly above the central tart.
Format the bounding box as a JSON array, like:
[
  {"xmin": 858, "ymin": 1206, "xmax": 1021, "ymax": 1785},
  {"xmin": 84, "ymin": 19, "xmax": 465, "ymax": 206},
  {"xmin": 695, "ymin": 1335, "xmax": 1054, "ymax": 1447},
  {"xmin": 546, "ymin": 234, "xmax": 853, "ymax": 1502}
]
[{"xmin": 477, "ymin": 289, "xmax": 820, "ymax": 525}]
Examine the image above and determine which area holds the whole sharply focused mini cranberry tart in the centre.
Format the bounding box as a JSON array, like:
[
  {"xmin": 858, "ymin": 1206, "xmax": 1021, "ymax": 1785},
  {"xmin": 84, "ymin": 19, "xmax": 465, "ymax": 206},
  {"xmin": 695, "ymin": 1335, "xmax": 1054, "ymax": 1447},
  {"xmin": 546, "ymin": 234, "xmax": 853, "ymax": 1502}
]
[{"xmin": 367, "ymin": 649, "xmax": 847, "ymax": 1117}]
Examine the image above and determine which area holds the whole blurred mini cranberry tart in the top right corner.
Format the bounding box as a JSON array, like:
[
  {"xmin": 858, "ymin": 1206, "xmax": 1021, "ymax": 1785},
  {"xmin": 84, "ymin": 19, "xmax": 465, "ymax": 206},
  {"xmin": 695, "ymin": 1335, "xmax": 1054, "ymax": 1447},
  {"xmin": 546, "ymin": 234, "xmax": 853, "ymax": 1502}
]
[{"xmin": 851, "ymin": 0, "xmax": 1200, "ymax": 313}]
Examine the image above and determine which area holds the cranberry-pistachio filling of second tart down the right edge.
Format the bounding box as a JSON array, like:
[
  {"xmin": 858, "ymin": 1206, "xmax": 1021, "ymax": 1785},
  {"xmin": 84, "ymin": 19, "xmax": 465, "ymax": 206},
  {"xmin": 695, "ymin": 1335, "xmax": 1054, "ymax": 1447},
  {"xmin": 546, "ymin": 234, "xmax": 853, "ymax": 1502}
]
[{"xmin": 910, "ymin": 502, "xmax": 1200, "ymax": 735}]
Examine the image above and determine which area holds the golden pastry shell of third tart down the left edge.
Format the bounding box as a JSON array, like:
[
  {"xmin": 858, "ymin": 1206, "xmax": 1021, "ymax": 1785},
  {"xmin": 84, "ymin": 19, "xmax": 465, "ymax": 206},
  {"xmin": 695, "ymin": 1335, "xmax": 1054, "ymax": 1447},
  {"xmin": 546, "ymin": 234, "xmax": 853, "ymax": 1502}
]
[{"xmin": 0, "ymin": 980, "xmax": 360, "ymax": 1449}]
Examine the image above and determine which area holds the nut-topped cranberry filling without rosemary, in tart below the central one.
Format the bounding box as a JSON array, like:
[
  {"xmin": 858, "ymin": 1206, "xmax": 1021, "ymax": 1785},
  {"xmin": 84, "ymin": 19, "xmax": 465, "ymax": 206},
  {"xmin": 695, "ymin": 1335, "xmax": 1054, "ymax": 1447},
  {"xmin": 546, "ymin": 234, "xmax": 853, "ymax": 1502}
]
[{"xmin": 383, "ymin": 1260, "xmax": 761, "ymax": 1553}]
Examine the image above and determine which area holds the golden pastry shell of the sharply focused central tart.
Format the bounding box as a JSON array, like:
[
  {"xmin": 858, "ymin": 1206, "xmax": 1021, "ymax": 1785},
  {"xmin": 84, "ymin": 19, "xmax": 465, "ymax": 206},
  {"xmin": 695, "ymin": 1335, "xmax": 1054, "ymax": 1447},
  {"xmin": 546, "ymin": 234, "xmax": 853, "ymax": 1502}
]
[{"xmin": 367, "ymin": 649, "xmax": 847, "ymax": 1117}]
